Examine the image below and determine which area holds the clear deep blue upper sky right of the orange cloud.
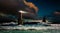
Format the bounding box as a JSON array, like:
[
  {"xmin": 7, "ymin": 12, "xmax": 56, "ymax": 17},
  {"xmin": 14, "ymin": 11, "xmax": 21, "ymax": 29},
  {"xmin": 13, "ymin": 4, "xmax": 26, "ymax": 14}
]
[{"xmin": 28, "ymin": 0, "xmax": 60, "ymax": 16}]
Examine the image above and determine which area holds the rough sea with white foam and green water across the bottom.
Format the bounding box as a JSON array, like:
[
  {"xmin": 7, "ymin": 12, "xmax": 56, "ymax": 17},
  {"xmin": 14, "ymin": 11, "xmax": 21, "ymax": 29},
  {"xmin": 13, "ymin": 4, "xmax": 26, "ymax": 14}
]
[{"xmin": 0, "ymin": 23, "xmax": 60, "ymax": 33}]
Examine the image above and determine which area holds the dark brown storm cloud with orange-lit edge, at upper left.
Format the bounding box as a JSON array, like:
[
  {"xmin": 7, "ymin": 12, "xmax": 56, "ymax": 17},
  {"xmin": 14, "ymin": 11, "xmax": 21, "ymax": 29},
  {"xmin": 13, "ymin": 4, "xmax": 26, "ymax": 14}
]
[{"xmin": 0, "ymin": 0, "xmax": 38, "ymax": 18}]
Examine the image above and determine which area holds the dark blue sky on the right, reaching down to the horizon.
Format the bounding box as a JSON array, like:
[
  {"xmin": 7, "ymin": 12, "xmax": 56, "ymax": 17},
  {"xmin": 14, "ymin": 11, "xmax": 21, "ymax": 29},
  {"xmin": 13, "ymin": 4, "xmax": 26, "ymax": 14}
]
[{"xmin": 28, "ymin": 0, "xmax": 60, "ymax": 23}]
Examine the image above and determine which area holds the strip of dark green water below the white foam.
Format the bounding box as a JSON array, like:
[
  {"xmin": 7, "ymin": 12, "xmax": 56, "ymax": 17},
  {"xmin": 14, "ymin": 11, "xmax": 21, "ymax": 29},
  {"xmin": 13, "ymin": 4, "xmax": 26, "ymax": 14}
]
[{"xmin": 0, "ymin": 29, "xmax": 60, "ymax": 33}]
